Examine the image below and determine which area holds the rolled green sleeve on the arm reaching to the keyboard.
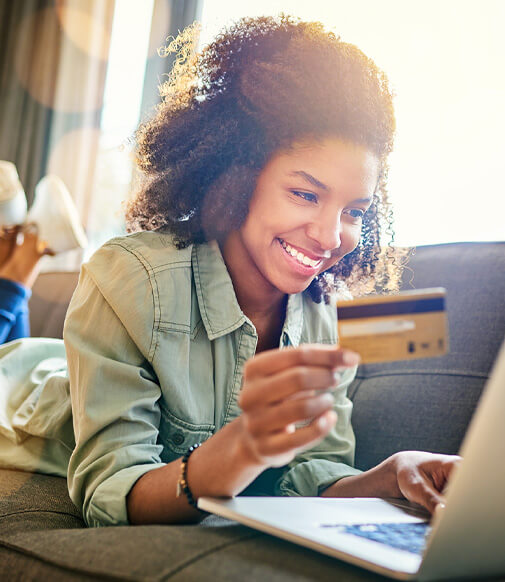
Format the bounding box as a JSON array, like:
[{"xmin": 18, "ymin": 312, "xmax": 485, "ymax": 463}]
[{"xmin": 275, "ymin": 368, "xmax": 361, "ymax": 497}]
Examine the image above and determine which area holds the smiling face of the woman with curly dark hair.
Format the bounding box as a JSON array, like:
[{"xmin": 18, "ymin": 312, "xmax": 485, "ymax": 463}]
[{"xmin": 223, "ymin": 139, "xmax": 379, "ymax": 310}]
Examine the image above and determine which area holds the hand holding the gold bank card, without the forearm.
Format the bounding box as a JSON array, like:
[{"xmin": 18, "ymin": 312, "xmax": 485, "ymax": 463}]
[{"xmin": 239, "ymin": 344, "xmax": 359, "ymax": 468}]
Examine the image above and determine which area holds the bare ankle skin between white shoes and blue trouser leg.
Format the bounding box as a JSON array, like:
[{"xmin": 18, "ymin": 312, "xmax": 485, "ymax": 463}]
[{"xmin": 0, "ymin": 227, "xmax": 53, "ymax": 289}]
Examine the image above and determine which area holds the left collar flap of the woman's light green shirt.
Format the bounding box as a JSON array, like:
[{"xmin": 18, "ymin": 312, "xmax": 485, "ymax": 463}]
[{"xmin": 191, "ymin": 241, "xmax": 246, "ymax": 340}]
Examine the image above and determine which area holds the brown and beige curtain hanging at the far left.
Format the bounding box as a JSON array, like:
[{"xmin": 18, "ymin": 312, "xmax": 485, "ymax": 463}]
[{"xmin": 0, "ymin": 0, "xmax": 114, "ymax": 224}]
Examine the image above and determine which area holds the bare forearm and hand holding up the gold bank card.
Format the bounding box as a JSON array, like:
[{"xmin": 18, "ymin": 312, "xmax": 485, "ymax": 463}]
[{"xmin": 127, "ymin": 344, "xmax": 359, "ymax": 524}]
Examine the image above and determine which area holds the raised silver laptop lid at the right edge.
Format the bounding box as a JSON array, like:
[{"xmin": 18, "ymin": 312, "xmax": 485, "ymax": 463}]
[{"xmin": 418, "ymin": 343, "xmax": 505, "ymax": 580}]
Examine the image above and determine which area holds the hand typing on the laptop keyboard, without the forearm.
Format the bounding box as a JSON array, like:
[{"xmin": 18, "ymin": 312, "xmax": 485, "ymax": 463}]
[{"xmin": 388, "ymin": 451, "xmax": 461, "ymax": 513}]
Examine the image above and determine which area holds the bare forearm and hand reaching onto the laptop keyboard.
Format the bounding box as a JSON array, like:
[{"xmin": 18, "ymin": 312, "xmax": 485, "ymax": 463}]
[{"xmin": 323, "ymin": 451, "xmax": 461, "ymax": 513}]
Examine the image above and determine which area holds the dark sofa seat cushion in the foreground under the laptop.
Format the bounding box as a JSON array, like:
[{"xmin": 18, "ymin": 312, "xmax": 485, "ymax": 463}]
[{"xmin": 0, "ymin": 470, "xmax": 382, "ymax": 582}]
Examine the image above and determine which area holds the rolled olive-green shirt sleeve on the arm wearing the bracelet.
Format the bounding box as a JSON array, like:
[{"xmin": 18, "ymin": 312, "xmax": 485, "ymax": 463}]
[{"xmin": 64, "ymin": 251, "xmax": 164, "ymax": 527}]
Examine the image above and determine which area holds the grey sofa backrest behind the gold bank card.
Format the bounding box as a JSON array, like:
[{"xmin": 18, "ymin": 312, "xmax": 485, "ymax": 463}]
[{"xmin": 350, "ymin": 243, "xmax": 505, "ymax": 469}]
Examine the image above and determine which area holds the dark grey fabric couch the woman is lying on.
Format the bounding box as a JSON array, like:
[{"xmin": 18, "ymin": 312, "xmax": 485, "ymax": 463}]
[{"xmin": 0, "ymin": 242, "xmax": 505, "ymax": 582}]
